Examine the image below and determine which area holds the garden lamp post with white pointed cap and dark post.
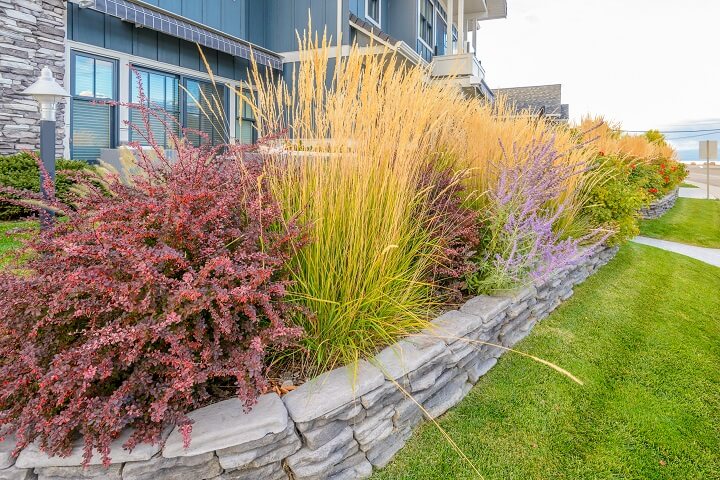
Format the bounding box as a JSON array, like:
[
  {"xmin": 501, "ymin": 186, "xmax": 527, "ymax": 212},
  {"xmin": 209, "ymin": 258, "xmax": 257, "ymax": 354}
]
[{"xmin": 22, "ymin": 67, "xmax": 70, "ymax": 228}]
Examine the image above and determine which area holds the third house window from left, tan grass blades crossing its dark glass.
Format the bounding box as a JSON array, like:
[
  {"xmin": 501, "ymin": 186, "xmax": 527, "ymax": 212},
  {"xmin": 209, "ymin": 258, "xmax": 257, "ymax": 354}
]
[{"xmin": 183, "ymin": 79, "xmax": 228, "ymax": 145}]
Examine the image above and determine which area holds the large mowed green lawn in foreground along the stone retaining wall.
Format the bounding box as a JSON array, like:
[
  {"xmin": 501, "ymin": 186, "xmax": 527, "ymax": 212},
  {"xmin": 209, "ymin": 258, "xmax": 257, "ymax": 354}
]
[{"xmin": 374, "ymin": 244, "xmax": 720, "ymax": 480}]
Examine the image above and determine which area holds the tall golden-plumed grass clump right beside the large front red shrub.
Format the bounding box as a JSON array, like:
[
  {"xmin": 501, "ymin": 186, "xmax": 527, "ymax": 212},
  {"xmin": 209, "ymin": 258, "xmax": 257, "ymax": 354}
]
[{"xmin": 248, "ymin": 33, "xmax": 476, "ymax": 374}]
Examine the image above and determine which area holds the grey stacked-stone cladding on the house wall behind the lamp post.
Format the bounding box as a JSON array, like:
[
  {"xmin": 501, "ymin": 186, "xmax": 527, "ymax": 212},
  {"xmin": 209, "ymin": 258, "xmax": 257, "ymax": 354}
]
[{"xmin": 0, "ymin": 0, "xmax": 68, "ymax": 156}]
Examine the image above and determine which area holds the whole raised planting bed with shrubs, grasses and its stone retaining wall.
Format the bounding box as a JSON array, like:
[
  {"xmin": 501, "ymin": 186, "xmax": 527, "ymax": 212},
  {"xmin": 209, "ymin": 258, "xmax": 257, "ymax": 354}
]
[{"xmin": 0, "ymin": 40, "xmax": 685, "ymax": 479}]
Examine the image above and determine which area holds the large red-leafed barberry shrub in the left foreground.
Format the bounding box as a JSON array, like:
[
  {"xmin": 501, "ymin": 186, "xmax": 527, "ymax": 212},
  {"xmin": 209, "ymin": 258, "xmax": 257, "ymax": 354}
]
[{"xmin": 0, "ymin": 95, "xmax": 300, "ymax": 464}]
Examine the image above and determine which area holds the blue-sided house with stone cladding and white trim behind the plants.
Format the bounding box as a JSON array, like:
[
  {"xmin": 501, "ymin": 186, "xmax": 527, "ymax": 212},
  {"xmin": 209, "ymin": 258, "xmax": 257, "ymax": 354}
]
[{"xmin": 0, "ymin": 0, "xmax": 507, "ymax": 161}]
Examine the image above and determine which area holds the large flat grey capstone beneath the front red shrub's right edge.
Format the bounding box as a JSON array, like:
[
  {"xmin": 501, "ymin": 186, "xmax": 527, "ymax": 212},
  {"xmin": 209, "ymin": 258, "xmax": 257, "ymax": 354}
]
[{"xmin": 163, "ymin": 393, "xmax": 288, "ymax": 458}]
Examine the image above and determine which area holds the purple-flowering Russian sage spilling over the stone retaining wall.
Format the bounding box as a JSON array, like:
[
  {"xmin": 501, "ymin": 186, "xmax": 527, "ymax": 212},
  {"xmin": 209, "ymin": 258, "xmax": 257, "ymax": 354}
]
[{"xmin": 468, "ymin": 137, "xmax": 604, "ymax": 293}]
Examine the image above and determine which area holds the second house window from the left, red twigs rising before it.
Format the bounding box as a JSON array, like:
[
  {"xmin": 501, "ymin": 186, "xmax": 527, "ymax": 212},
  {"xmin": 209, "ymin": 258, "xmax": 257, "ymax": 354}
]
[{"xmin": 130, "ymin": 67, "xmax": 180, "ymax": 148}]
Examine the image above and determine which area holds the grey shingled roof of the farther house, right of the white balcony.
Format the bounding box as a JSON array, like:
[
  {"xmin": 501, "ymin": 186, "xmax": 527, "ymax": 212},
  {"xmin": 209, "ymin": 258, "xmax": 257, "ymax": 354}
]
[{"xmin": 495, "ymin": 84, "xmax": 570, "ymax": 123}]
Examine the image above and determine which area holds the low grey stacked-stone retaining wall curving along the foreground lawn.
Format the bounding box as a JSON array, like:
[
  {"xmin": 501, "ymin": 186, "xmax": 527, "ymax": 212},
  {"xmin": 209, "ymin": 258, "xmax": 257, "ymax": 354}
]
[{"xmin": 0, "ymin": 247, "xmax": 618, "ymax": 480}]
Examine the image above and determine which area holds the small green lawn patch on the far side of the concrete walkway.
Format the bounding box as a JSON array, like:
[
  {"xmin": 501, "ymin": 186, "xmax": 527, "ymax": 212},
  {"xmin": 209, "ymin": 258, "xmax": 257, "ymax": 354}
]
[{"xmin": 640, "ymin": 198, "xmax": 720, "ymax": 248}]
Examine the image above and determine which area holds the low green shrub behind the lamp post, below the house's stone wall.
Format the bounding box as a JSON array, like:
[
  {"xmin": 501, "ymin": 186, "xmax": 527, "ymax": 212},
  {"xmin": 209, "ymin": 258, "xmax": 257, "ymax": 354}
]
[{"xmin": 0, "ymin": 152, "xmax": 88, "ymax": 221}]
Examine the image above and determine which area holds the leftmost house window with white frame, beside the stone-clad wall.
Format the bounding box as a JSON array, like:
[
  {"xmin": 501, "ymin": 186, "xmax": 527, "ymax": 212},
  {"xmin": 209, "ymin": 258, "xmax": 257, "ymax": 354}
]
[{"xmin": 70, "ymin": 52, "xmax": 117, "ymax": 162}]
